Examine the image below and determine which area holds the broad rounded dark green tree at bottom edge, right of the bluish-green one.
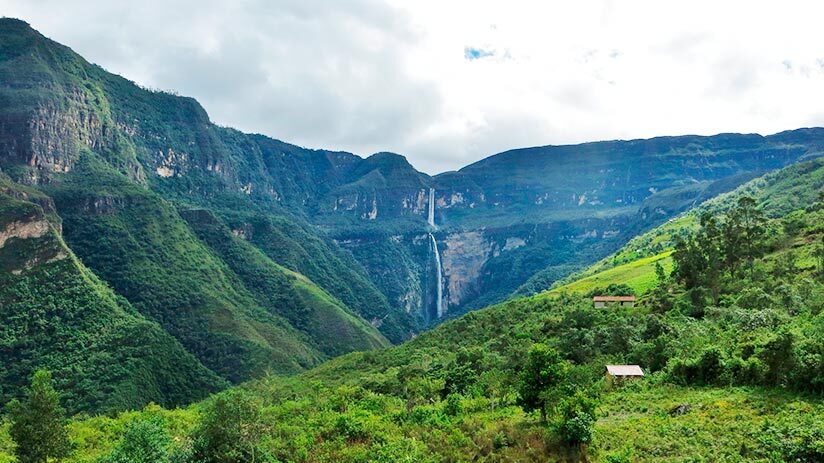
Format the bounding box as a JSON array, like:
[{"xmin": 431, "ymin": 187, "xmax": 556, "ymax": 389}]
[{"xmin": 193, "ymin": 390, "xmax": 264, "ymax": 463}]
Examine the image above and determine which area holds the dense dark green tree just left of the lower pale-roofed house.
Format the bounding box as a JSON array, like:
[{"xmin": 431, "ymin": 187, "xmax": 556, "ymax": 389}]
[{"xmin": 518, "ymin": 343, "xmax": 567, "ymax": 423}]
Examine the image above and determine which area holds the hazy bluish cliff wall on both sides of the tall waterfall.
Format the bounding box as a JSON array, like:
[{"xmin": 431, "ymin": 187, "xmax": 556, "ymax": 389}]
[{"xmin": 311, "ymin": 129, "xmax": 824, "ymax": 321}]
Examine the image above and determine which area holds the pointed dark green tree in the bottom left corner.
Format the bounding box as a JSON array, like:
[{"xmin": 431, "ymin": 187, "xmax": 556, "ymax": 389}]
[{"xmin": 9, "ymin": 370, "xmax": 70, "ymax": 463}]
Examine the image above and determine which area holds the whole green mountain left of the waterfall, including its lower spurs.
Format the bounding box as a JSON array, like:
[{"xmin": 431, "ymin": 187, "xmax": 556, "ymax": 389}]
[{"xmin": 0, "ymin": 19, "xmax": 392, "ymax": 411}]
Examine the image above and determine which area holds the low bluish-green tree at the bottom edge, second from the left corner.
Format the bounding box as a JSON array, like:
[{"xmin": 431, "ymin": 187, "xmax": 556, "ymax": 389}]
[{"xmin": 101, "ymin": 417, "xmax": 172, "ymax": 463}]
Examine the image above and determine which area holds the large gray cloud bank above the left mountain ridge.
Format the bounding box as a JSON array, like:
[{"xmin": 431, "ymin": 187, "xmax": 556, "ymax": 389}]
[{"xmin": 0, "ymin": 0, "xmax": 442, "ymax": 169}]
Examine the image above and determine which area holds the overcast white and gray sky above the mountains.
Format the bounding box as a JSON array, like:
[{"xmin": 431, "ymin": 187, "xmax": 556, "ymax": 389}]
[{"xmin": 0, "ymin": 0, "xmax": 824, "ymax": 173}]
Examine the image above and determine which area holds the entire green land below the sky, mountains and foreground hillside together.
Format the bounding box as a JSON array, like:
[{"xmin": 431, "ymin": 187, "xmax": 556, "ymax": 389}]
[{"xmin": 0, "ymin": 18, "xmax": 824, "ymax": 463}]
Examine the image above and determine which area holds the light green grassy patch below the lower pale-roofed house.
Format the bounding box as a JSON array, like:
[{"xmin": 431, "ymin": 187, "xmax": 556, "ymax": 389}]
[{"xmin": 597, "ymin": 385, "xmax": 824, "ymax": 463}]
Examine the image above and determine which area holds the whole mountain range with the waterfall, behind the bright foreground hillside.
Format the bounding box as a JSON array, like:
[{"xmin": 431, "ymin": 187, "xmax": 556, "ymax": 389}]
[{"xmin": 0, "ymin": 19, "xmax": 824, "ymax": 410}]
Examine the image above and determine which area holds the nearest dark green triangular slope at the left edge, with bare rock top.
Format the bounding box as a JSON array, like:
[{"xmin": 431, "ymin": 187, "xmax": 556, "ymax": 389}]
[{"xmin": 0, "ymin": 177, "xmax": 226, "ymax": 412}]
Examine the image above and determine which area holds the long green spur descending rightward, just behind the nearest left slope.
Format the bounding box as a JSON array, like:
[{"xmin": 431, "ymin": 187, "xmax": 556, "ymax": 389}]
[{"xmin": 44, "ymin": 156, "xmax": 332, "ymax": 381}]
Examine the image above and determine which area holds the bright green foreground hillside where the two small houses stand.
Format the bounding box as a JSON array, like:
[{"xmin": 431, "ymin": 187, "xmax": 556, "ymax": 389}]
[{"xmin": 0, "ymin": 153, "xmax": 824, "ymax": 462}]
